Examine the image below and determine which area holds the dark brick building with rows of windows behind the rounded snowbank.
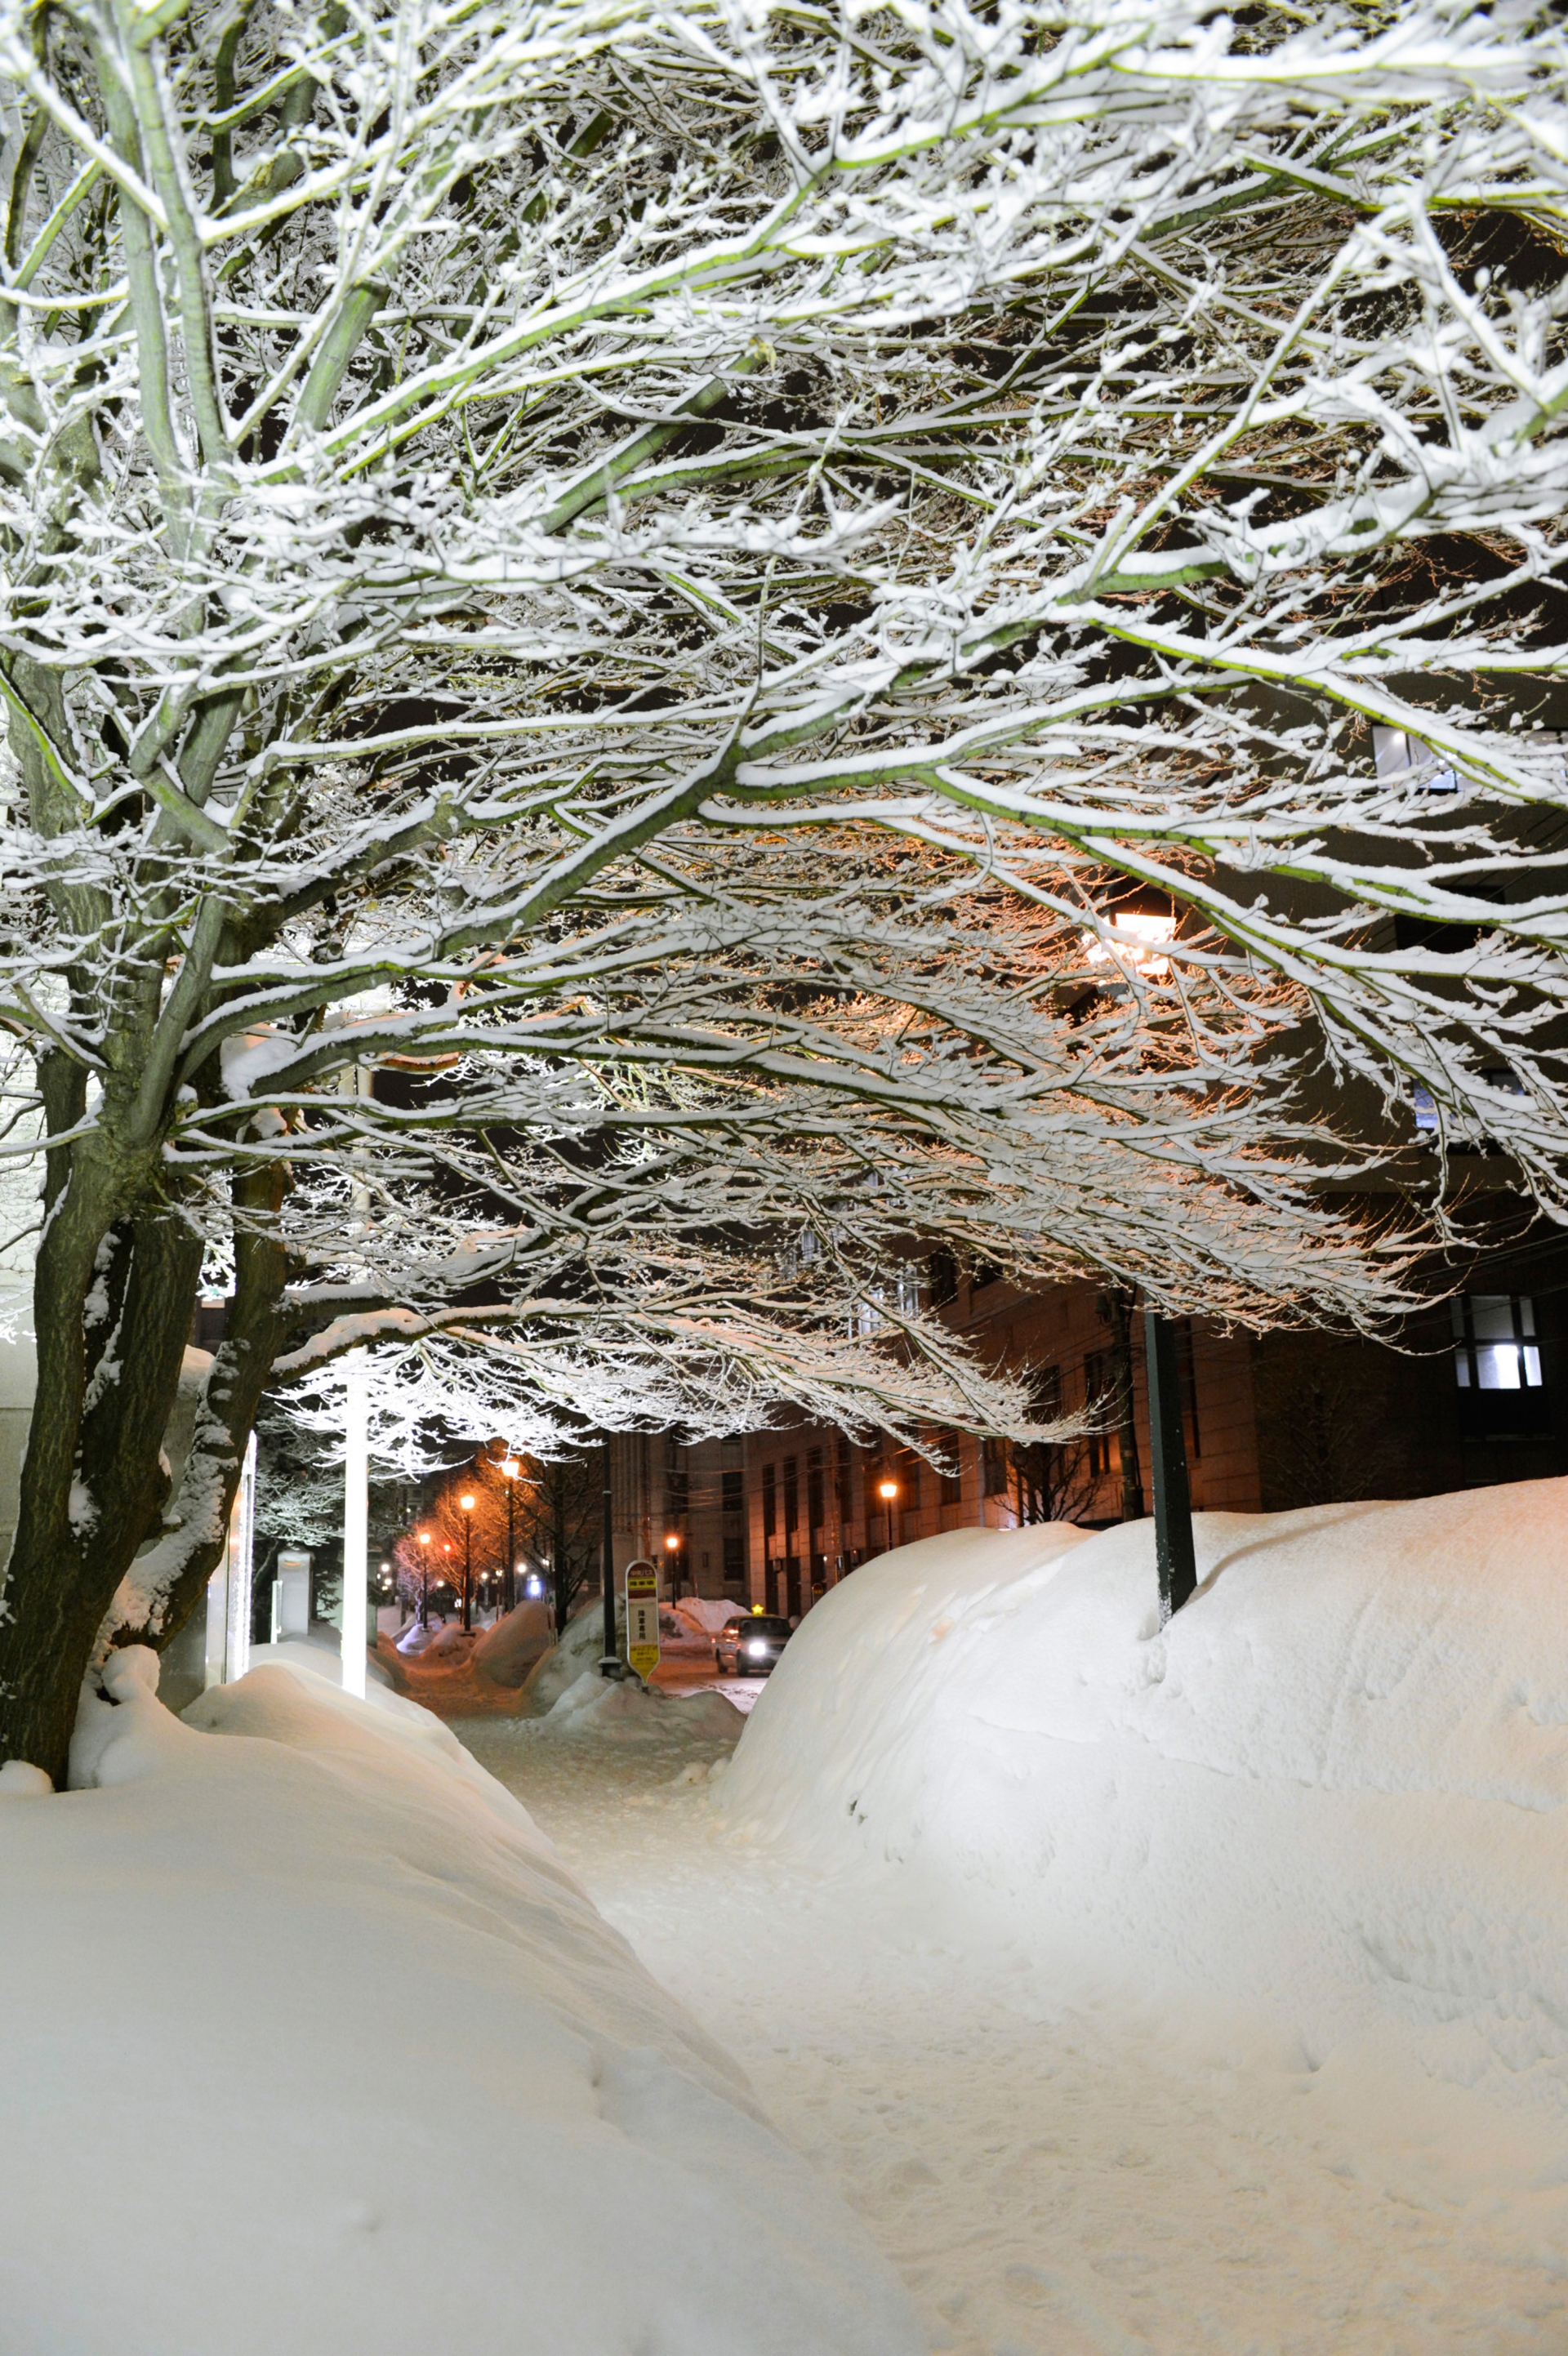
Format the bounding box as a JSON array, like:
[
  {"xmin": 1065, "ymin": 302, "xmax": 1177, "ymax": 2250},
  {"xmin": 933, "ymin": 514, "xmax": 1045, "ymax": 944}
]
[{"xmin": 614, "ymin": 1220, "xmax": 1568, "ymax": 1616}]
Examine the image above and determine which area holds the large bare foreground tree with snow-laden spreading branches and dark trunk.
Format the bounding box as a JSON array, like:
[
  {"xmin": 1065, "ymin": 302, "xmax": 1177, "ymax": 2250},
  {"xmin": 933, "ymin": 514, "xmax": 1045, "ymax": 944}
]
[{"xmin": 0, "ymin": 0, "xmax": 1568, "ymax": 1767}]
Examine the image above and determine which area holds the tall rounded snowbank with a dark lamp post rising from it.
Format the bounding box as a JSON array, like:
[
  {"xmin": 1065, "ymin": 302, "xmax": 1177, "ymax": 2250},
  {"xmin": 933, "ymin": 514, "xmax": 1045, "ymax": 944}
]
[{"xmin": 718, "ymin": 1482, "xmax": 1568, "ymax": 2116}]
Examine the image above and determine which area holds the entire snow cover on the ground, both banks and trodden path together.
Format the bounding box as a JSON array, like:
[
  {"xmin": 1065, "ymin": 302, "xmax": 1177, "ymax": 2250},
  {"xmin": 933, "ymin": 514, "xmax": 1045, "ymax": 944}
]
[{"xmin": 11, "ymin": 1485, "xmax": 1568, "ymax": 2356}]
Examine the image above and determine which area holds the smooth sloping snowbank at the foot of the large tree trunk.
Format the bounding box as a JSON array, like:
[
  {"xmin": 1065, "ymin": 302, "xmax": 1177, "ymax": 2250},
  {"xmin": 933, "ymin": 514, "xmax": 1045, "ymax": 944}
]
[{"xmin": 0, "ymin": 1651, "xmax": 923, "ymax": 2356}]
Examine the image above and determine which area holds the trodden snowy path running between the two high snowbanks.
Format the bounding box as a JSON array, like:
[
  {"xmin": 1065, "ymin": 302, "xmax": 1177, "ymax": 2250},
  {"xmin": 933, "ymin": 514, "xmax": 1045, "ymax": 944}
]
[{"xmin": 454, "ymin": 1715, "xmax": 1568, "ymax": 2356}]
